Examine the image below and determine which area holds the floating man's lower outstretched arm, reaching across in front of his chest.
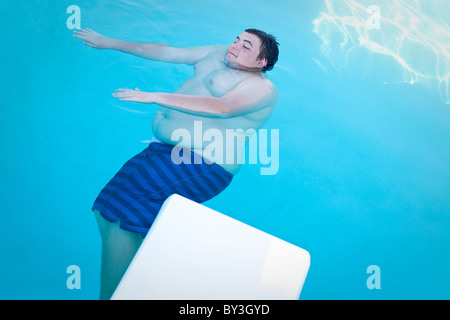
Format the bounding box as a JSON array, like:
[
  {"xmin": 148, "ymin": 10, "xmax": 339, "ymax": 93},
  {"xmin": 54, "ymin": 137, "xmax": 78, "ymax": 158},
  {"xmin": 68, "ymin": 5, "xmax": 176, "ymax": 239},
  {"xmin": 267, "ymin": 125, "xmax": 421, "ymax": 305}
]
[{"xmin": 113, "ymin": 78, "xmax": 273, "ymax": 118}]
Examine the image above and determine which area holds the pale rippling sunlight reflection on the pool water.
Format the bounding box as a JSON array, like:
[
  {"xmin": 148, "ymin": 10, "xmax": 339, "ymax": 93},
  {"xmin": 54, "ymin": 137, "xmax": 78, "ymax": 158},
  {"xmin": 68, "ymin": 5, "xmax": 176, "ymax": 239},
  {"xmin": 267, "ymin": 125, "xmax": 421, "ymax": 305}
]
[{"xmin": 313, "ymin": 0, "xmax": 450, "ymax": 104}]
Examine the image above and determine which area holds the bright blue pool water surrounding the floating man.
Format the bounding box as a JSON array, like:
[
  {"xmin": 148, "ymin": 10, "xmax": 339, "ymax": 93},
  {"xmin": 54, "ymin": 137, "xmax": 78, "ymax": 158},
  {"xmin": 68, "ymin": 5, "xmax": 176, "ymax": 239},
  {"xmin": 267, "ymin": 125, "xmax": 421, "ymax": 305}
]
[{"xmin": 0, "ymin": 0, "xmax": 450, "ymax": 299}]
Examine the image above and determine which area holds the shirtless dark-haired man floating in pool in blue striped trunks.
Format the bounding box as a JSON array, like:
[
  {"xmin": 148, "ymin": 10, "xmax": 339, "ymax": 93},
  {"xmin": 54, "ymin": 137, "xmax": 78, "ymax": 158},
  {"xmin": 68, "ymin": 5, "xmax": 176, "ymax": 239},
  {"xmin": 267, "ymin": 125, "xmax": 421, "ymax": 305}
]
[{"xmin": 74, "ymin": 28, "xmax": 278, "ymax": 299}]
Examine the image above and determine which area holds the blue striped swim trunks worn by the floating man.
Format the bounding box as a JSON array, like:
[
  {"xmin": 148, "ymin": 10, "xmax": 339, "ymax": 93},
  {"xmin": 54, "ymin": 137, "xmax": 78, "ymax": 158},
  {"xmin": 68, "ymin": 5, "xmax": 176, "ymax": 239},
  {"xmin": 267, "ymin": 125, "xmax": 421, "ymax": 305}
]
[{"xmin": 92, "ymin": 142, "xmax": 233, "ymax": 234}]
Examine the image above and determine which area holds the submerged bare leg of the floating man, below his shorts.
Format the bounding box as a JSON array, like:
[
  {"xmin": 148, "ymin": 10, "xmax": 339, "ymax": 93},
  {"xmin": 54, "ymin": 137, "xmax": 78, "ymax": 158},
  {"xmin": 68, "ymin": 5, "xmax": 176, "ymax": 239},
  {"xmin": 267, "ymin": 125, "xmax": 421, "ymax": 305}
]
[{"xmin": 94, "ymin": 210, "xmax": 142, "ymax": 300}]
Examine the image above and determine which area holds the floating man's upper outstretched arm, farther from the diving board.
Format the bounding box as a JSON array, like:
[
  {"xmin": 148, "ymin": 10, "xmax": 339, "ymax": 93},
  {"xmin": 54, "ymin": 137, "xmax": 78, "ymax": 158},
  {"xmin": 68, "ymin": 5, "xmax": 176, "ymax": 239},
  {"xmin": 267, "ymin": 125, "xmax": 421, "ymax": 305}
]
[{"xmin": 73, "ymin": 28, "xmax": 220, "ymax": 64}]
